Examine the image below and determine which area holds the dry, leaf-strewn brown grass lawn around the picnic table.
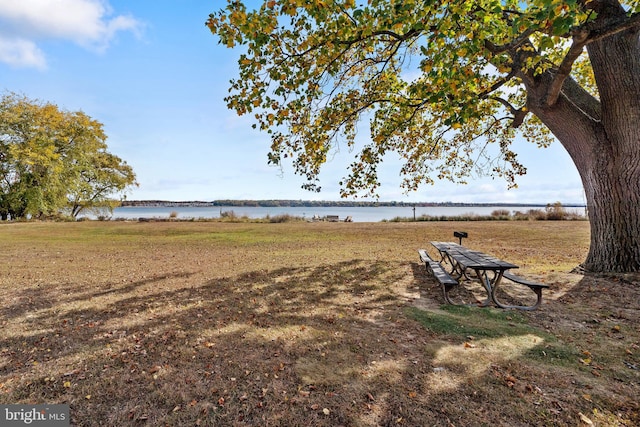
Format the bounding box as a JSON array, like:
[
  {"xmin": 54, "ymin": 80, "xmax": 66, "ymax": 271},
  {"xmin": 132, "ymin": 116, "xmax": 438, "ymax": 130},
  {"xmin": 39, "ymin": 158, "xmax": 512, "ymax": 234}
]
[{"xmin": 0, "ymin": 221, "xmax": 640, "ymax": 426}]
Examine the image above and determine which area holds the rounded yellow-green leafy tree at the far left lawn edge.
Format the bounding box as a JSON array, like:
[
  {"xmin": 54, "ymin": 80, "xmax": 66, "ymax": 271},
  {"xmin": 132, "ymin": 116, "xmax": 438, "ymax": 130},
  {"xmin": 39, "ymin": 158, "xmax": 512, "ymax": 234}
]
[{"xmin": 0, "ymin": 93, "xmax": 135, "ymax": 219}]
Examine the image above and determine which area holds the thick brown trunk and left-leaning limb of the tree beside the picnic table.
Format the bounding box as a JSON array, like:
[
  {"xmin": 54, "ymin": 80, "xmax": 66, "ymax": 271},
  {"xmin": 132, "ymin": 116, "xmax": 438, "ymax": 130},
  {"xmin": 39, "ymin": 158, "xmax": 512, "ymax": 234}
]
[{"xmin": 525, "ymin": 5, "xmax": 640, "ymax": 272}]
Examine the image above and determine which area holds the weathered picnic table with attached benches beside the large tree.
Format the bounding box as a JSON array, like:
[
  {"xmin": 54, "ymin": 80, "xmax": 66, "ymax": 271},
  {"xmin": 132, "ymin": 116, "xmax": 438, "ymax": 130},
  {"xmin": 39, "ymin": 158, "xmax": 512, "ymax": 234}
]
[{"xmin": 418, "ymin": 235, "xmax": 549, "ymax": 310}]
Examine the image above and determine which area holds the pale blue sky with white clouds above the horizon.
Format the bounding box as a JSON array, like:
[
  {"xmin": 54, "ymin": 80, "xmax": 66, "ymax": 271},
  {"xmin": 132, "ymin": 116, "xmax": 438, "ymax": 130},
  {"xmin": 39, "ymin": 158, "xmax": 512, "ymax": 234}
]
[{"xmin": 0, "ymin": 0, "xmax": 584, "ymax": 203}]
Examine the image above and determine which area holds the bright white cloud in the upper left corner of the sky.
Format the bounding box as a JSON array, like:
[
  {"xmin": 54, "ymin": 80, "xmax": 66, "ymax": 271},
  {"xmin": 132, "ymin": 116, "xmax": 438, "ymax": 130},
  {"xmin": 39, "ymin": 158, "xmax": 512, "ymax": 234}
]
[{"xmin": 0, "ymin": 0, "xmax": 142, "ymax": 68}]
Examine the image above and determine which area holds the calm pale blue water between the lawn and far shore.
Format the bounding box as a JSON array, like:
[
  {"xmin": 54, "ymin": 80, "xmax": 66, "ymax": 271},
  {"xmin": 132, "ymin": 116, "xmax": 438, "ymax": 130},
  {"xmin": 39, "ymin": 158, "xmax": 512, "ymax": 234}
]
[{"xmin": 97, "ymin": 206, "xmax": 584, "ymax": 222}]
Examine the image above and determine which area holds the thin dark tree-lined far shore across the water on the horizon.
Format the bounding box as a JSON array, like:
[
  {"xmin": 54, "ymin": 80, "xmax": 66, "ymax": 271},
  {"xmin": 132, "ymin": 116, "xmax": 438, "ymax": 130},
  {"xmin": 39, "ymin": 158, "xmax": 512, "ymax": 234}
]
[{"xmin": 121, "ymin": 200, "xmax": 585, "ymax": 208}]
